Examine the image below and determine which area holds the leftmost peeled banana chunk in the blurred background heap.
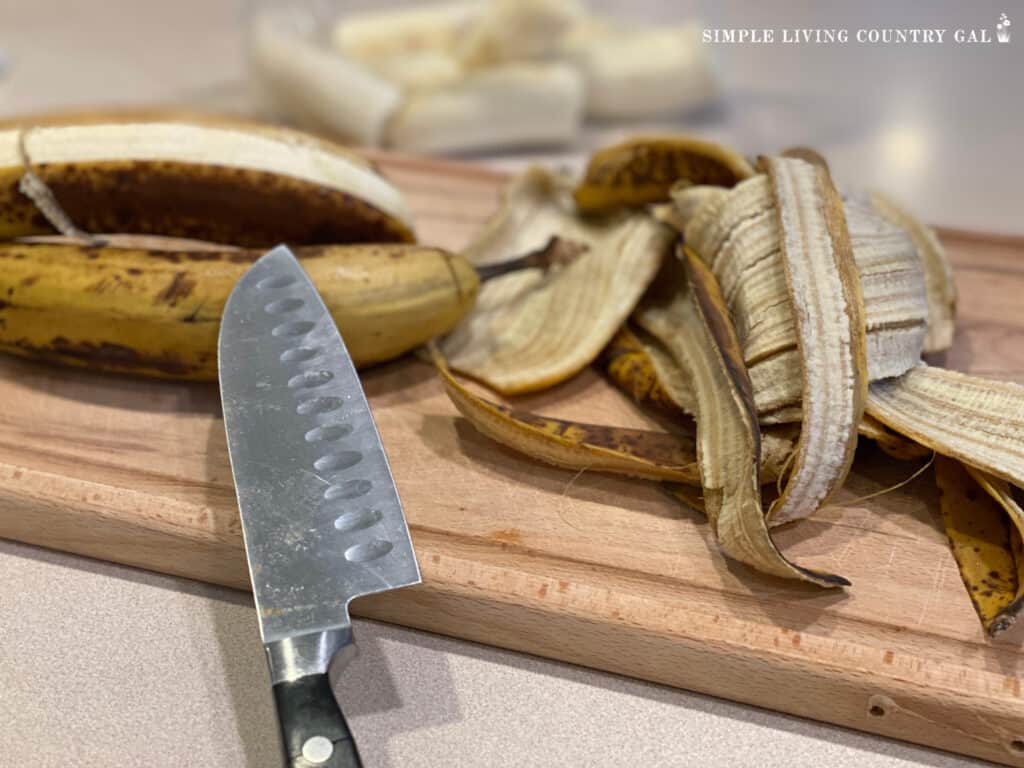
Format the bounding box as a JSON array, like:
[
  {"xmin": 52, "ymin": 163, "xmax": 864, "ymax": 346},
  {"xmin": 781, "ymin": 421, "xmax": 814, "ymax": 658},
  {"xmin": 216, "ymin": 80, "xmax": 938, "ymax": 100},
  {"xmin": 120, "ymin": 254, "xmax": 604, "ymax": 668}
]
[{"xmin": 249, "ymin": 11, "xmax": 403, "ymax": 146}]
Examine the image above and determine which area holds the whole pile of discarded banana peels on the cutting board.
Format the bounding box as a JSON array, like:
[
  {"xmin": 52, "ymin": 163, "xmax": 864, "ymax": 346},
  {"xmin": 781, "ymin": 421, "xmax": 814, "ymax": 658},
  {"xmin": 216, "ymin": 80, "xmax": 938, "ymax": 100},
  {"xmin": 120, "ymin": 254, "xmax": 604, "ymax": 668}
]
[{"xmin": 433, "ymin": 137, "xmax": 1024, "ymax": 636}]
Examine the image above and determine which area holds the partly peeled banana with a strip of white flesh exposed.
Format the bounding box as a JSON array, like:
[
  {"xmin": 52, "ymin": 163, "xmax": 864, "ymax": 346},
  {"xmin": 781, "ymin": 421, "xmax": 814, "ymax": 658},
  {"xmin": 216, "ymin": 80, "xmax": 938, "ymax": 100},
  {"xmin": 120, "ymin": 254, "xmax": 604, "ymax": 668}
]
[{"xmin": 0, "ymin": 123, "xmax": 414, "ymax": 247}]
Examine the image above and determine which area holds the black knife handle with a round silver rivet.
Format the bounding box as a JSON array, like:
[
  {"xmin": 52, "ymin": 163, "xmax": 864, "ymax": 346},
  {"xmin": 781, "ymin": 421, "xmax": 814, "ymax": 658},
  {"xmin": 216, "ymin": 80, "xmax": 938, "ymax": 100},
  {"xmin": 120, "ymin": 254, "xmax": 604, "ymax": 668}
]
[{"xmin": 273, "ymin": 674, "xmax": 362, "ymax": 768}]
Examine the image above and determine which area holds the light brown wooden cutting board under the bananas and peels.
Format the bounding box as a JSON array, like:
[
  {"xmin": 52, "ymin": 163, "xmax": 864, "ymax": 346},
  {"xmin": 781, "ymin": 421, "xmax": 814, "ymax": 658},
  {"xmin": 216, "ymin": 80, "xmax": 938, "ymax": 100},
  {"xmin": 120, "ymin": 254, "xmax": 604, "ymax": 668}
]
[{"xmin": 0, "ymin": 156, "xmax": 1024, "ymax": 766}]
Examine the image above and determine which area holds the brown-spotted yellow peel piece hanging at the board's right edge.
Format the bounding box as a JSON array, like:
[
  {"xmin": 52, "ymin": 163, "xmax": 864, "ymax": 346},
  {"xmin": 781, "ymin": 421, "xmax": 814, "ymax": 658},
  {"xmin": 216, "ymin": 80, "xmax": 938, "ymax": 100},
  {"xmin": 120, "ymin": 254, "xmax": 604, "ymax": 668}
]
[{"xmin": 935, "ymin": 456, "xmax": 1024, "ymax": 637}]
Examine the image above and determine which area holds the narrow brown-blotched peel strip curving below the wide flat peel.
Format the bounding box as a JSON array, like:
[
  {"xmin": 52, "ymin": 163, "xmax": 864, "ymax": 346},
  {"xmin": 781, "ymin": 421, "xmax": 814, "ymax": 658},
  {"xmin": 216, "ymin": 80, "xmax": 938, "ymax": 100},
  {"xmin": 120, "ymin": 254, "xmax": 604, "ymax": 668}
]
[{"xmin": 434, "ymin": 358, "xmax": 699, "ymax": 484}]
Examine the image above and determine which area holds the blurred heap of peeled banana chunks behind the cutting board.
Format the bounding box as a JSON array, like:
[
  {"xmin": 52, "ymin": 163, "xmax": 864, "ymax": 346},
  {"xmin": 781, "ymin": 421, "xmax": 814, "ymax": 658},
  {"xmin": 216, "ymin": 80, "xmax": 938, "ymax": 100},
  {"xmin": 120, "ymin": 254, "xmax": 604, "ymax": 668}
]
[{"xmin": 260, "ymin": 0, "xmax": 716, "ymax": 152}]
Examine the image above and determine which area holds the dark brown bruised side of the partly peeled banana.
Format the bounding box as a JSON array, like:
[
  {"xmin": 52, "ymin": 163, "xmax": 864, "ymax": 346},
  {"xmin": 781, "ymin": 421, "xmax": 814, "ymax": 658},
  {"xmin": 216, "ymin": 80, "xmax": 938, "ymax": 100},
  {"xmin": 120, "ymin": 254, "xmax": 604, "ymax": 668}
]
[{"xmin": 0, "ymin": 160, "xmax": 414, "ymax": 248}]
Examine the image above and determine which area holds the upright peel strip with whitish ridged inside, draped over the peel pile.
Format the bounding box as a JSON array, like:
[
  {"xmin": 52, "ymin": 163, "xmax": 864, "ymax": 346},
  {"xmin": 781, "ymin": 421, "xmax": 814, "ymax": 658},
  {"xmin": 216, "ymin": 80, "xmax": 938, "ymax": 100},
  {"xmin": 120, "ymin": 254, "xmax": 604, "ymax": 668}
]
[{"xmin": 765, "ymin": 156, "xmax": 868, "ymax": 523}]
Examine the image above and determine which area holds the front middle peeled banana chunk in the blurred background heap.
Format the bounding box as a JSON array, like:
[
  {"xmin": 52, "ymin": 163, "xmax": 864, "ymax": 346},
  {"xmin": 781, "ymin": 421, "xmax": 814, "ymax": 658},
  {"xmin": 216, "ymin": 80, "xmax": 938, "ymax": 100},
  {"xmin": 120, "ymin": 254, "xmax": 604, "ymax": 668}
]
[{"xmin": 387, "ymin": 63, "xmax": 583, "ymax": 153}]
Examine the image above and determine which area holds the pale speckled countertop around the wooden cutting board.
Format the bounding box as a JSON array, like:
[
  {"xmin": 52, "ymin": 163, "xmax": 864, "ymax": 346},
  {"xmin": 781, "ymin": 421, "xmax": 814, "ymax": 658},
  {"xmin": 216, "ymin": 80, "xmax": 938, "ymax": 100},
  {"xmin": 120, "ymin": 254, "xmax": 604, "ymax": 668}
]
[{"xmin": 0, "ymin": 0, "xmax": 1024, "ymax": 768}]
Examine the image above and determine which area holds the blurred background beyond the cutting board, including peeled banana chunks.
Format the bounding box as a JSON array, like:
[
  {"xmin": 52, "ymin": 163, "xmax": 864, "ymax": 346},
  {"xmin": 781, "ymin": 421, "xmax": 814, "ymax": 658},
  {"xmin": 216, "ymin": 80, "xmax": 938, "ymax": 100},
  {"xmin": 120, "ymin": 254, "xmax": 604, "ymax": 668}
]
[{"xmin": 0, "ymin": 0, "xmax": 1024, "ymax": 234}]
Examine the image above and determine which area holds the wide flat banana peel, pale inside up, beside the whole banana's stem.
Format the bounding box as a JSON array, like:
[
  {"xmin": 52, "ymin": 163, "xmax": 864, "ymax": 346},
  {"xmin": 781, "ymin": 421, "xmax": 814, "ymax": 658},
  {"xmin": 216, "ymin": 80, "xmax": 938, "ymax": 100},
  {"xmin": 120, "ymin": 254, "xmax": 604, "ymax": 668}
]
[{"xmin": 441, "ymin": 168, "xmax": 675, "ymax": 394}]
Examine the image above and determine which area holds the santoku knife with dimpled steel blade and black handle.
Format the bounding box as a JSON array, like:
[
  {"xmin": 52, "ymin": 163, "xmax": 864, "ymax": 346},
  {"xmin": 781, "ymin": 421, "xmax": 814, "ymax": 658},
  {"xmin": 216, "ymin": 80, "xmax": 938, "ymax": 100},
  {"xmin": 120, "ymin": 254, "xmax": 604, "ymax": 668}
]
[{"xmin": 218, "ymin": 246, "xmax": 420, "ymax": 768}]
